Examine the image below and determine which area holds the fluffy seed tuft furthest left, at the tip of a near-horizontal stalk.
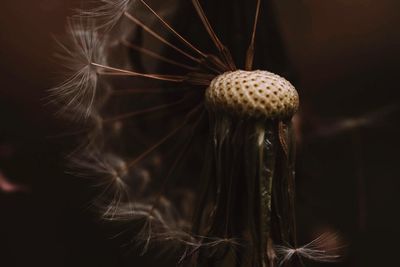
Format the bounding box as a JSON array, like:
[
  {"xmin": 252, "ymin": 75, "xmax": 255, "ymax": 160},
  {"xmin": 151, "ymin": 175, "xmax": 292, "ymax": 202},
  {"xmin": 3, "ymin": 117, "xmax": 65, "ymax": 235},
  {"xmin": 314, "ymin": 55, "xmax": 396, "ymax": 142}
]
[{"xmin": 50, "ymin": 20, "xmax": 106, "ymax": 118}]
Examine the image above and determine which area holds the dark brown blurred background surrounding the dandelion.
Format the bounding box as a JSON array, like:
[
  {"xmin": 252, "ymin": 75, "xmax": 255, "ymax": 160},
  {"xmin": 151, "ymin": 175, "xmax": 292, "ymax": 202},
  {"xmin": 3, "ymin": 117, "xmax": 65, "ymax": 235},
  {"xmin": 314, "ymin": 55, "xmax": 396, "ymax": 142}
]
[{"xmin": 0, "ymin": 0, "xmax": 400, "ymax": 267}]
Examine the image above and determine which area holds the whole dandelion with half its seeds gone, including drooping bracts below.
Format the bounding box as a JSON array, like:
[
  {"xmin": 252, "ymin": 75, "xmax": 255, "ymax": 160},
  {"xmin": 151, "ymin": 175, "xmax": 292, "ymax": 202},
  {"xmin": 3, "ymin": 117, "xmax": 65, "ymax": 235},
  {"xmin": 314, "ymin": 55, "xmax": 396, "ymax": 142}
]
[{"xmin": 52, "ymin": 0, "xmax": 340, "ymax": 267}]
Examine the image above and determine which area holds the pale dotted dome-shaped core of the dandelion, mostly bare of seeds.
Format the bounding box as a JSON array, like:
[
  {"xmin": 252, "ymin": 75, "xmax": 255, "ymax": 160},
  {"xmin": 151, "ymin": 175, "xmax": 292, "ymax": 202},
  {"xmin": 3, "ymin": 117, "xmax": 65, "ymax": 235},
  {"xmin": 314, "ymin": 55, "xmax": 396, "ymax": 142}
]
[{"xmin": 206, "ymin": 70, "xmax": 299, "ymax": 119}]
